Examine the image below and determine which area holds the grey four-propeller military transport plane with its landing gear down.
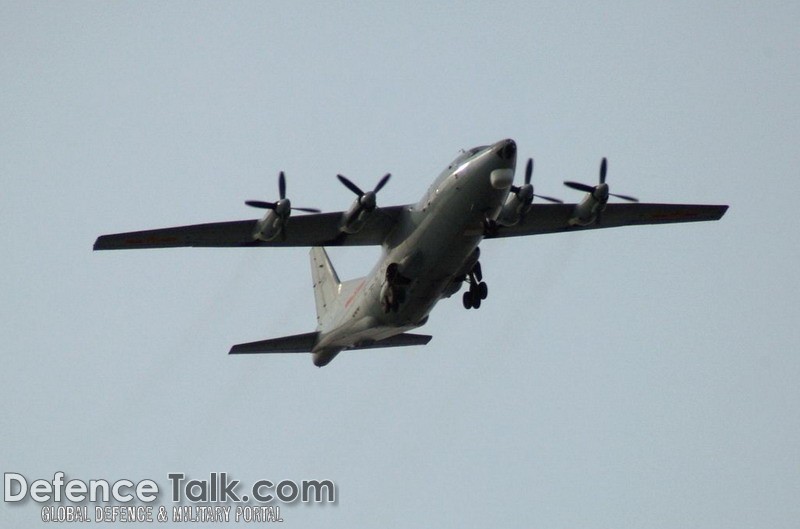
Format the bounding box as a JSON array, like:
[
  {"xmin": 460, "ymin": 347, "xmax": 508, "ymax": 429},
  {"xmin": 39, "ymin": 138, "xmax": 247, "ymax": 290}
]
[{"xmin": 94, "ymin": 139, "xmax": 728, "ymax": 366}]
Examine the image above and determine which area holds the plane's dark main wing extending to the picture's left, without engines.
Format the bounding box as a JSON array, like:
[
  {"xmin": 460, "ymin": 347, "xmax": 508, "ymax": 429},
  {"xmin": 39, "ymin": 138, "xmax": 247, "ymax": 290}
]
[{"xmin": 94, "ymin": 206, "xmax": 408, "ymax": 250}]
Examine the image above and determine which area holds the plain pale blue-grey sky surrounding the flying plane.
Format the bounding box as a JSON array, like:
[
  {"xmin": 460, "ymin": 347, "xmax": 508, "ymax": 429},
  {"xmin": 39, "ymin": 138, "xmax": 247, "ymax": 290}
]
[{"xmin": 0, "ymin": 1, "xmax": 800, "ymax": 529}]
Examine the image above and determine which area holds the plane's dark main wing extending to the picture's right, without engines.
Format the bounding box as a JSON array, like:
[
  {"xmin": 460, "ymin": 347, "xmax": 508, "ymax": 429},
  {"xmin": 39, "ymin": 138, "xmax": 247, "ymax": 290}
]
[{"xmin": 476, "ymin": 203, "xmax": 728, "ymax": 239}]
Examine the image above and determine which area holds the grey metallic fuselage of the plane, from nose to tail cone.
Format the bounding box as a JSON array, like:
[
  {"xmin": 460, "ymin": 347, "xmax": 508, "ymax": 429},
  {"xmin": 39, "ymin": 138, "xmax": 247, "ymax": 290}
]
[{"xmin": 314, "ymin": 140, "xmax": 516, "ymax": 365}]
